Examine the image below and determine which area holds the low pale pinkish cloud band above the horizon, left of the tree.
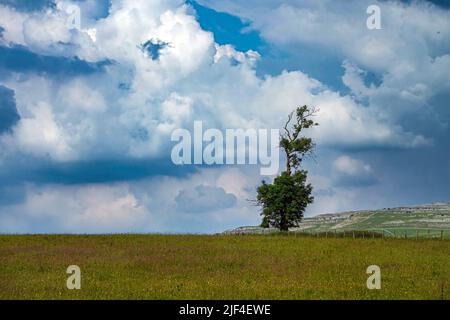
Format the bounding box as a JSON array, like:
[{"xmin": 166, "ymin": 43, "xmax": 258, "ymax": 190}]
[{"xmin": 0, "ymin": 168, "xmax": 259, "ymax": 233}]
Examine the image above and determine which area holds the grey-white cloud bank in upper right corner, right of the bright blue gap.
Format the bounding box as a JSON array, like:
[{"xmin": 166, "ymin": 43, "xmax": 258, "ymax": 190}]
[{"xmin": 200, "ymin": 0, "xmax": 450, "ymax": 141}]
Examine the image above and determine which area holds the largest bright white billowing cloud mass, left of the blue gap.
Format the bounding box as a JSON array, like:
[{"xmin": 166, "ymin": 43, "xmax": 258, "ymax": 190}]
[{"xmin": 2, "ymin": 1, "xmax": 426, "ymax": 165}]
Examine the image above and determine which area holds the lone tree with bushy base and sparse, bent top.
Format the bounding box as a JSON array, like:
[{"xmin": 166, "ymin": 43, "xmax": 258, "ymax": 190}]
[{"xmin": 257, "ymin": 106, "xmax": 318, "ymax": 231}]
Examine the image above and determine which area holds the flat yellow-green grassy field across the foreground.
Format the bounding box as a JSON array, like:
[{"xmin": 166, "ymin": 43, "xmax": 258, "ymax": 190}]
[{"xmin": 0, "ymin": 235, "xmax": 450, "ymax": 299}]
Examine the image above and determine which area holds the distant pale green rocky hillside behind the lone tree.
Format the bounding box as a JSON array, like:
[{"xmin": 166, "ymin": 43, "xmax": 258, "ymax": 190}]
[{"xmin": 225, "ymin": 203, "xmax": 450, "ymax": 234}]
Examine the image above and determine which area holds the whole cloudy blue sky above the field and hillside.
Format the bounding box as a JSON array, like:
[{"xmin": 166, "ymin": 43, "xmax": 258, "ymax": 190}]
[{"xmin": 0, "ymin": 0, "xmax": 450, "ymax": 233}]
